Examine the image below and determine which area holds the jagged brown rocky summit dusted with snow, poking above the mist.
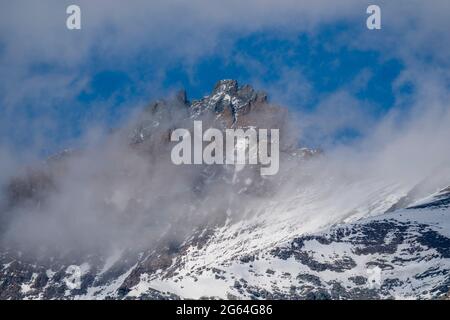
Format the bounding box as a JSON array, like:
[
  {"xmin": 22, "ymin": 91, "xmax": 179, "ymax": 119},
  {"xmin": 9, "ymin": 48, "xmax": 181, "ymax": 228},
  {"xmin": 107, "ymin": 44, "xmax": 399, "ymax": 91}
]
[{"xmin": 131, "ymin": 80, "xmax": 294, "ymax": 148}]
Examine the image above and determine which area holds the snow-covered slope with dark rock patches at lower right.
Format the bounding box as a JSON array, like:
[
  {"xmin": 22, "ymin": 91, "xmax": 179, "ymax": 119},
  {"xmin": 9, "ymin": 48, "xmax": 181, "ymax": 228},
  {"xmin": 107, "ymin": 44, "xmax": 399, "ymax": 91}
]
[{"xmin": 138, "ymin": 202, "xmax": 450, "ymax": 299}]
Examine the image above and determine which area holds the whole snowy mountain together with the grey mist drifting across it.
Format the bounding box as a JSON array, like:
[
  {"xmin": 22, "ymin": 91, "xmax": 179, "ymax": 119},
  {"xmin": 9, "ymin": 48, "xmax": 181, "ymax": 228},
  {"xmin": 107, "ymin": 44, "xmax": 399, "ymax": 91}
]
[{"xmin": 0, "ymin": 80, "xmax": 450, "ymax": 299}]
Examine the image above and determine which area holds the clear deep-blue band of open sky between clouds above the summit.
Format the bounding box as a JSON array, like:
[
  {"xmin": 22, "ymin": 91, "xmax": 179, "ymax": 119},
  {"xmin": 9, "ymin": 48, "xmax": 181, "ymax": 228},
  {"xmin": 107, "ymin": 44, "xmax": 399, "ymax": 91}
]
[{"xmin": 78, "ymin": 29, "xmax": 402, "ymax": 113}]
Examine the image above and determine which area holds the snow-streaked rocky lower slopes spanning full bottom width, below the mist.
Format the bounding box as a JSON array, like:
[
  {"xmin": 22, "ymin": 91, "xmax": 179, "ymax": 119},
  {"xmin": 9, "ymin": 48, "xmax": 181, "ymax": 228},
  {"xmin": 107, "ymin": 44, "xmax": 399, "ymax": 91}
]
[{"xmin": 0, "ymin": 185, "xmax": 450, "ymax": 299}]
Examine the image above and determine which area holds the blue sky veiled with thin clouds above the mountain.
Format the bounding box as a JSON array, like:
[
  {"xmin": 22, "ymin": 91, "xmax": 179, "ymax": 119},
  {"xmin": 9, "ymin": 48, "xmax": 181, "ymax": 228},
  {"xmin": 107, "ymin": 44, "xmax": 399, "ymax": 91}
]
[{"xmin": 0, "ymin": 0, "xmax": 448, "ymax": 158}]
